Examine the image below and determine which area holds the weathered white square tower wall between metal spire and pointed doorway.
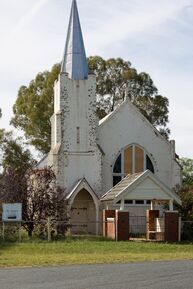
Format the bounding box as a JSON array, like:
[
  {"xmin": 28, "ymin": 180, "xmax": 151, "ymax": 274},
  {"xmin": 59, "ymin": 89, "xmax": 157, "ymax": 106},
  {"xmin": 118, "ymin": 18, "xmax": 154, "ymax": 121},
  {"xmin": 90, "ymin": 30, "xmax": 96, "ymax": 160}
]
[{"xmin": 49, "ymin": 73, "xmax": 102, "ymax": 195}]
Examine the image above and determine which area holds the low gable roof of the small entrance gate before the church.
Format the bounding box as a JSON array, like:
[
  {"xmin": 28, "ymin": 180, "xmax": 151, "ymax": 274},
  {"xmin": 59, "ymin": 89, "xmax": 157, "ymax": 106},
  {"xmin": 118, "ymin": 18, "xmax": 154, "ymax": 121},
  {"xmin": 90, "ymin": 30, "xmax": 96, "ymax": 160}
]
[{"xmin": 101, "ymin": 170, "xmax": 181, "ymax": 204}]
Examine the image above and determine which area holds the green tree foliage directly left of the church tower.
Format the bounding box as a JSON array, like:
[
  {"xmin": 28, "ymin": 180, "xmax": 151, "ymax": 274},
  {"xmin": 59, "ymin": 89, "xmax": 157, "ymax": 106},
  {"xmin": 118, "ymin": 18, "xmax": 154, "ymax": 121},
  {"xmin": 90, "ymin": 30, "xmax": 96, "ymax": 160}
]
[{"xmin": 11, "ymin": 64, "xmax": 60, "ymax": 153}]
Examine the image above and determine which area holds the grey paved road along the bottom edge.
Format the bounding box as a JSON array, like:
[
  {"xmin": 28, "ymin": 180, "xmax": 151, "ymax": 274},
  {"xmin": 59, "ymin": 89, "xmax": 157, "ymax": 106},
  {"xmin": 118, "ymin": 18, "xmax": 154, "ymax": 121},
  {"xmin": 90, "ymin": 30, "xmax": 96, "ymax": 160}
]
[{"xmin": 0, "ymin": 261, "xmax": 193, "ymax": 289}]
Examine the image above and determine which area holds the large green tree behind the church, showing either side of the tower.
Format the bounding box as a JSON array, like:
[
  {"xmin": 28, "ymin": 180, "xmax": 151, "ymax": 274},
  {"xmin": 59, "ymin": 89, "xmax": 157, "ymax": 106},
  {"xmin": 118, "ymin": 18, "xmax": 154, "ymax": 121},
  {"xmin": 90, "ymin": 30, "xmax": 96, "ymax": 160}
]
[{"xmin": 11, "ymin": 56, "xmax": 169, "ymax": 153}]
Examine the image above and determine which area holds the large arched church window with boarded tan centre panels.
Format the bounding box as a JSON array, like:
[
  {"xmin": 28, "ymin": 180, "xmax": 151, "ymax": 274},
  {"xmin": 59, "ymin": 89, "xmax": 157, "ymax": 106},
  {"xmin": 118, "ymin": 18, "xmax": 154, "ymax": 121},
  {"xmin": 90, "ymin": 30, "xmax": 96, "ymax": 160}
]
[{"xmin": 113, "ymin": 145, "xmax": 155, "ymax": 186}]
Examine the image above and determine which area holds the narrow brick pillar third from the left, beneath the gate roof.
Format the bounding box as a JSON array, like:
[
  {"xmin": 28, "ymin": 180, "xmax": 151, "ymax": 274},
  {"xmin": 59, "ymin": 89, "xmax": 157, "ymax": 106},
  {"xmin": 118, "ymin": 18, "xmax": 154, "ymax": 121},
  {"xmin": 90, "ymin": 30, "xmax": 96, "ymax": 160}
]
[{"xmin": 147, "ymin": 210, "xmax": 159, "ymax": 240}]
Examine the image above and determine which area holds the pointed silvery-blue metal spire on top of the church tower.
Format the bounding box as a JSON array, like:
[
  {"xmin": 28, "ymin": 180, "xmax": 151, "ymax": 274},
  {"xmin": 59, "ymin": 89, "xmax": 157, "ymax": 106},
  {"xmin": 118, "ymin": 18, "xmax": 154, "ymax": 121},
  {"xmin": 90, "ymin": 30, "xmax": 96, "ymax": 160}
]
[{"xmin": 61, "ymin": 0, "xmax": 88, "ymax": 80}]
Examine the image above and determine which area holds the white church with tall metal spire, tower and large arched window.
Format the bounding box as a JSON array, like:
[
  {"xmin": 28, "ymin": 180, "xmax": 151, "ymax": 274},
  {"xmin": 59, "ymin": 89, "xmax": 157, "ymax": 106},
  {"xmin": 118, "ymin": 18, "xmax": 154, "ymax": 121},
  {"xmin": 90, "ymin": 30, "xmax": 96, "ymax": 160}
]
[{"xmin": 38, "ymin": 0, "xmax": 181, "ymax": 233}]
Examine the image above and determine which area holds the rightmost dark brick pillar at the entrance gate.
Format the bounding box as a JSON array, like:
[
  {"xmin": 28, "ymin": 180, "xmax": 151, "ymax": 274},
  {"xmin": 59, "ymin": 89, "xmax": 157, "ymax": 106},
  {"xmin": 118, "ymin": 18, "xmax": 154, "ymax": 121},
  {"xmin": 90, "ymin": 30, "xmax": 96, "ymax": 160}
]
[{"xmin": 165, "ymin": 211, "xmax": 179, "ymax": 242}]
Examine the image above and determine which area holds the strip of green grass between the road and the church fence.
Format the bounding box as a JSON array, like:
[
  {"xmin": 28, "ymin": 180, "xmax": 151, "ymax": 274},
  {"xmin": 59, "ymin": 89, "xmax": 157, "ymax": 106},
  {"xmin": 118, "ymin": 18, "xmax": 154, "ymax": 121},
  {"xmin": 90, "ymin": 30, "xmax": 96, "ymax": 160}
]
[{"xmin": 0, "ymin": 237, "xmax": 193, "ymax": 268}]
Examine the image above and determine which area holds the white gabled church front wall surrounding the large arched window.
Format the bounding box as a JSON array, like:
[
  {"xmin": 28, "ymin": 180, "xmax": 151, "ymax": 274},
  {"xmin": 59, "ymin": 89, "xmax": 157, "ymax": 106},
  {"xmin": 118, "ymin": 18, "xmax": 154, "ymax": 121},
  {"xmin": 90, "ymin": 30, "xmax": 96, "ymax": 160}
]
[{"xmin": 98, "ymin": 100, "xmax": 181, "ymax": 192}]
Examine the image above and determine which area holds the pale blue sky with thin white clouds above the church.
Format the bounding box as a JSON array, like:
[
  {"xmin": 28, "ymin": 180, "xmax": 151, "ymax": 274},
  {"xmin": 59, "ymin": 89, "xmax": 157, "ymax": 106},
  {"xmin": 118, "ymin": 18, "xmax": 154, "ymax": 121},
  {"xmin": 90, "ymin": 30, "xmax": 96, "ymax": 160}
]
[{"xmin": 0, "ymin": 0, "xmax": 193, "ymax": 158}]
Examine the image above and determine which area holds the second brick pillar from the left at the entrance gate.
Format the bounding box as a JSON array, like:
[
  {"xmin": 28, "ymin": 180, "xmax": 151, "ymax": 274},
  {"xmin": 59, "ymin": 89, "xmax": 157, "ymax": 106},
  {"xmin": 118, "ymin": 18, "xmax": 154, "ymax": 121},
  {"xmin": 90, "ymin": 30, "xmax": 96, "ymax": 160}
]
[{"xmin": 115, "ymin": 210, "xmax": 129, "ymax": 241}]
